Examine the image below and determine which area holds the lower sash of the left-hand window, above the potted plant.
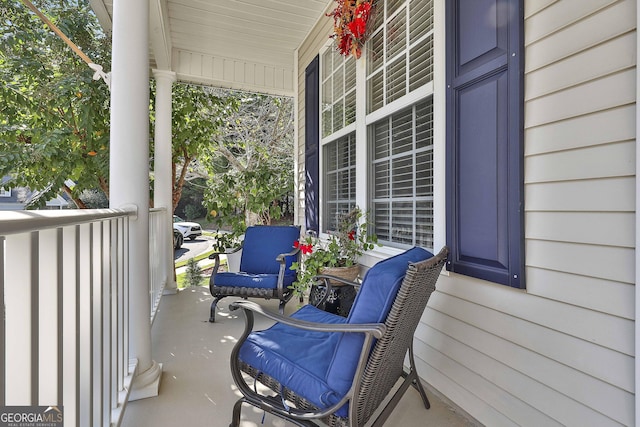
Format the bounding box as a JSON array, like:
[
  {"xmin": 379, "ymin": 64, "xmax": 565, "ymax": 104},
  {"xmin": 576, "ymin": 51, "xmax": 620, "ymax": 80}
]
[{"xmin": 322, "ymin": 133, "xmax": 356, "ymax": 230}]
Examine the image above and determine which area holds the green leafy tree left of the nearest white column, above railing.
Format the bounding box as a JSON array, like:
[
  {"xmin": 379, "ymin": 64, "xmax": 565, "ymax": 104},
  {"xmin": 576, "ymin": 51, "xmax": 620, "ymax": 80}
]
[{"xmin": 0, "ymin": 0, "xmax": 111, "ymax": 207}]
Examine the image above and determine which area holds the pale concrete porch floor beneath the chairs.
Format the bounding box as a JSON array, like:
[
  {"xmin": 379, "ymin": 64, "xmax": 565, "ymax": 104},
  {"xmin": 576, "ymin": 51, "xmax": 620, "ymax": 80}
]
[{"xmin": 122, "ymin": 287, "xmax": 475, "ymax": 427}]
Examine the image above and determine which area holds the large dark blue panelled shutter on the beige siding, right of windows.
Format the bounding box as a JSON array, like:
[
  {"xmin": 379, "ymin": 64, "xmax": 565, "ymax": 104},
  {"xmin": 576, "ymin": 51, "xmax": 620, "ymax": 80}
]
[{"xmin": 446, "ymin": 0, "xmax": 525, "ymax": 288}]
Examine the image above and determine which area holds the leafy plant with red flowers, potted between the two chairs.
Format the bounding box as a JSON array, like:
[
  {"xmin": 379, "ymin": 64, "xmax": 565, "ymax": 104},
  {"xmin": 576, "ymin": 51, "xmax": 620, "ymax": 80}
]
[{"xmin": 291, "ymin": 206, "xmax": 378, "ymax": 308}]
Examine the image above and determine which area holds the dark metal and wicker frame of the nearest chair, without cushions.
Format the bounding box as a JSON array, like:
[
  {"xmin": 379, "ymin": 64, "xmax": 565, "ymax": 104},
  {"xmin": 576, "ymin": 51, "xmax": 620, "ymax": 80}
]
[{"xmin": 230, "ymin": 247, "xmax": 448, "ymax": 427}]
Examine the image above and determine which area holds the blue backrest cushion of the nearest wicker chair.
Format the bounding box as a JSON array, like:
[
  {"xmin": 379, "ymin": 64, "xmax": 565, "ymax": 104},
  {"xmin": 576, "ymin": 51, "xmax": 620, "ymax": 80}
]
[{"xmin": 327, "ymin": 247, "xmax": 433, "ymax": 393}]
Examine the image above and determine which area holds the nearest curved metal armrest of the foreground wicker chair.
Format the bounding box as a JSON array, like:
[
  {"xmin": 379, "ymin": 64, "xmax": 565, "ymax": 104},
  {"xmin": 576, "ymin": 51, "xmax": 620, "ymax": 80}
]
[{"xmin": 229, "ymin": 301, "xmax": 387, "ymax": 339}]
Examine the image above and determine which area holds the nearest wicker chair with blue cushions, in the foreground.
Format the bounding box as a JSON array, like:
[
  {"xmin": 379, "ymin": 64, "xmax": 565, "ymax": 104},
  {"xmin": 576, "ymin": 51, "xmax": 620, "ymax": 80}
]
[{"xmin": 230, "ymin": 247, "xmax": 448, "ymax": 427}]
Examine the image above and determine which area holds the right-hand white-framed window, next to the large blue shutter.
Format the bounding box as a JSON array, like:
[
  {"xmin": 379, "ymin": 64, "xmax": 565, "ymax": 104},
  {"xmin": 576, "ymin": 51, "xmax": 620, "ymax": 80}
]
[{"xmin": 366, "ymin": 0, "xmax": 433, "ymax": 249}]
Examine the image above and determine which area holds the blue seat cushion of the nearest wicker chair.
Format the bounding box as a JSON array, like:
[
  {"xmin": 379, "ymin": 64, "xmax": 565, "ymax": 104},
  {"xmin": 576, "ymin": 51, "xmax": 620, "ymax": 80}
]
[{"xmin": 239, "ymin": 305, "xmax": 348, "ymax": 416}]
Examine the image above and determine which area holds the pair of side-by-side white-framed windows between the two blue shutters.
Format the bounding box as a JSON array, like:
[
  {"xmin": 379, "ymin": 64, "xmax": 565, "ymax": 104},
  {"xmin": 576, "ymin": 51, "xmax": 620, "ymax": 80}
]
[{"xmin": 307, "ymin": 0, "xmax": 434, "ymax": 249}]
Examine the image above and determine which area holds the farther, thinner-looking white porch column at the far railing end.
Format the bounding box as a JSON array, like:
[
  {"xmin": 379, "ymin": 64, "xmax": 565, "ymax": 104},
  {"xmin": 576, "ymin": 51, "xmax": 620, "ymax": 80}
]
[{"xmin": 153, "ymin": 70, "xmax": 177, "ymax": 294}]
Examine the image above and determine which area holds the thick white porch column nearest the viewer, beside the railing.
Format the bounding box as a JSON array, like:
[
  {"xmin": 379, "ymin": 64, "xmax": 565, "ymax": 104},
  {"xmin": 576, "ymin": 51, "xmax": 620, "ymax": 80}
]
[{"xmin": 109, "ymin": 0, "xmax": 162, "ymax": 399}]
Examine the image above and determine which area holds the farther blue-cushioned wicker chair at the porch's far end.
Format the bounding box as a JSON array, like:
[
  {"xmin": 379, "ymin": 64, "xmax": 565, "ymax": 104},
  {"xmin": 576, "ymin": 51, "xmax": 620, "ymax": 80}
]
[{"xmin": 209, "ymin": 225, "xmax": 300, "ymax": 323}]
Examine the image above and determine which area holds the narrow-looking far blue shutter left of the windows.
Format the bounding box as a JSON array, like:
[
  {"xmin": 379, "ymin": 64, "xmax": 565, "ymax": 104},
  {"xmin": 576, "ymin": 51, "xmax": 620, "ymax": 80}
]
[{"xmin": 304, "ymin": 56, "xmax": 320, "ymax": 233}]
